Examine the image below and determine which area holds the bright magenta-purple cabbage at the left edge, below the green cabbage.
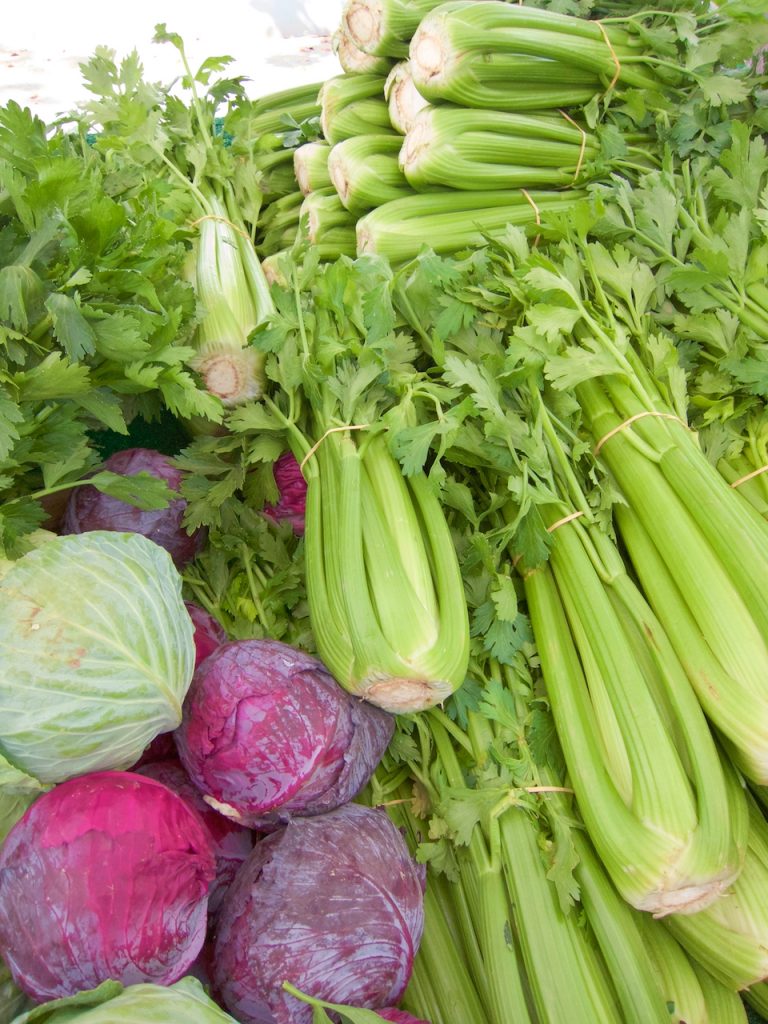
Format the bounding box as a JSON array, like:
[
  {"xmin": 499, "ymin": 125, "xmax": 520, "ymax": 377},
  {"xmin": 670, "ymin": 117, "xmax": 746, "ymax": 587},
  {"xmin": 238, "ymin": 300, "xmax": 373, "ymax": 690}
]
[{"xmin": 0, "ymin": 771, "xmax": 215, "ymax": 1002}]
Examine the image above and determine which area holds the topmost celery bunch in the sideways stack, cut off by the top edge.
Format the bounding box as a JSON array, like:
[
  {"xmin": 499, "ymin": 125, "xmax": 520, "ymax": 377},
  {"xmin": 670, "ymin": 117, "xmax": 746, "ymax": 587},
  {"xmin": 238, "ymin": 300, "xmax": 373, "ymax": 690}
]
[{"xmin": 341, "ymin": 0, "xmax": 450, "ymax": 57}]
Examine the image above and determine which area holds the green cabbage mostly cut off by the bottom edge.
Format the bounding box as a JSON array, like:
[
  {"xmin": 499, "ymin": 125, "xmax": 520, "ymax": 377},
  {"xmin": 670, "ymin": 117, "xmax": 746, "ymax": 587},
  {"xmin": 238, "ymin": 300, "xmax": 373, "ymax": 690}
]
[{"xmin": 7, "ymin": 978, "xmax": 238, "ymax": 1024}]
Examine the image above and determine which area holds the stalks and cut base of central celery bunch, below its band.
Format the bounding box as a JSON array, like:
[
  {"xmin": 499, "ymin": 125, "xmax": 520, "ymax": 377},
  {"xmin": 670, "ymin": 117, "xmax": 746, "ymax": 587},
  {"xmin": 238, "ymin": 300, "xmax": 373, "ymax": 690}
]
[{"xmin": 305, "ymin": 430, "xmax": 469, "ymax": 712}]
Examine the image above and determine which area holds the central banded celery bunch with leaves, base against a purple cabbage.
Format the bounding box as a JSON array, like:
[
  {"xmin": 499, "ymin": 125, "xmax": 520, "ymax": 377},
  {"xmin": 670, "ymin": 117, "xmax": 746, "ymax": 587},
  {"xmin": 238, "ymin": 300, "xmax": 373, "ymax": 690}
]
[{"xmin": 257, "ymin": 256, "xmax": 469, "ymax": 712}]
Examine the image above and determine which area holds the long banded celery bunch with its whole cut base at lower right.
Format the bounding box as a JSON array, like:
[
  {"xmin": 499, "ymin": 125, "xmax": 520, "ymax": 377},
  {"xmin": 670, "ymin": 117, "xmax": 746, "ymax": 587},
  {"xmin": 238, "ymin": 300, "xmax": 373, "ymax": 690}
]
[{"xmin": 378, "ymin": 233, "xmax": 746, "ymax": 915}]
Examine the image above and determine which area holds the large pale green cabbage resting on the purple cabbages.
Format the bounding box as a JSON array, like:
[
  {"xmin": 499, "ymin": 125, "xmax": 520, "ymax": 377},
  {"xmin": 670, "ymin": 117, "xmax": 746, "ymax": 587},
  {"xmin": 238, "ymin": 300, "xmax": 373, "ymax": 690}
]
[{"xmin": 0, "ymin": 530, "xmax": 195, "ymax": 782}]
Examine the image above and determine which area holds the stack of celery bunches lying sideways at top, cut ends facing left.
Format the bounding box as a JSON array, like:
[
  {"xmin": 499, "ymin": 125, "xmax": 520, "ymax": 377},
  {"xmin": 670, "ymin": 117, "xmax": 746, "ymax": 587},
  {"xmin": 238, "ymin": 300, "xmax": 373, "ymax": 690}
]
[{"xmin": 270, "ymin": 0, "xmax": 745, "ymax": 261}]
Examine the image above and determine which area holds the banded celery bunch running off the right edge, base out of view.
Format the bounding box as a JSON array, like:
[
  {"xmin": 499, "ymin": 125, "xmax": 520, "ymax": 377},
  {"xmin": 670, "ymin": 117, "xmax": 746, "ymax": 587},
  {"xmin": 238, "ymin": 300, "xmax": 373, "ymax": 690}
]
[{"xmin": 438, "ymin": 221, "xmax": 768, "ymax": 782}]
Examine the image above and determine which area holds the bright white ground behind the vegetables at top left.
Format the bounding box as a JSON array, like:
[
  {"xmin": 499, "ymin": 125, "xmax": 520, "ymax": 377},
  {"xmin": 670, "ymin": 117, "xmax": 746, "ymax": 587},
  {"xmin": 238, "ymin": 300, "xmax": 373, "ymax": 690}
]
[{"xmin": 0, "ymin": 0, "xmax": 342, "ymax": 121}]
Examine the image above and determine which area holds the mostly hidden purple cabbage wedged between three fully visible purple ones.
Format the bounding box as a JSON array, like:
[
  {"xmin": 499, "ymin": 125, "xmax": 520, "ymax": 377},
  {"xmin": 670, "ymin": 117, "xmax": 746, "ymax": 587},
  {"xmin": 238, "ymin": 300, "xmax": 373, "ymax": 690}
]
[{"xmin": 139, "ymin": 761, "xmax": 254, "ymax": 914}]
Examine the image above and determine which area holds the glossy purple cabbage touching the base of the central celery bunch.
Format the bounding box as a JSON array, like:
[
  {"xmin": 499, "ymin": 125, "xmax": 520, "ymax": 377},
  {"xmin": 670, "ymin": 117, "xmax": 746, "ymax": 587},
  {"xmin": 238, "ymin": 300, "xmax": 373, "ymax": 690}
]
[{"xmin": 176, "ymin": 640, "xmax": 394, "ymax": 830}]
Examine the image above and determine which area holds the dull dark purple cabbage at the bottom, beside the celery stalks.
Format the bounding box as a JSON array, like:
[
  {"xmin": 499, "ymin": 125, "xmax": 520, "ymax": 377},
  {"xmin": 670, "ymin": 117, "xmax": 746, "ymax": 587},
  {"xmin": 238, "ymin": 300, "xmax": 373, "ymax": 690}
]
[{"xmin": 213, "ymin": 804, "xmax": 424, "ymax": 1024}]
